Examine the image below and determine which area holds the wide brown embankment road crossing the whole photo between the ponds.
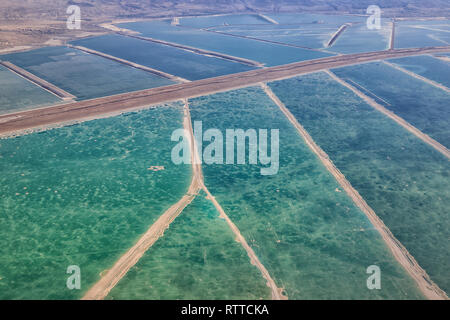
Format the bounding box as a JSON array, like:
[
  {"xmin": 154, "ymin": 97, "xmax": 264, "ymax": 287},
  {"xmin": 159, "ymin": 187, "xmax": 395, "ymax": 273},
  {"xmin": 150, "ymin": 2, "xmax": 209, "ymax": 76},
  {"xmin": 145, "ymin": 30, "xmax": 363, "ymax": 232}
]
[{"xmin": 0, "ymin": 47, "xmax": 450, "ymax": 137}]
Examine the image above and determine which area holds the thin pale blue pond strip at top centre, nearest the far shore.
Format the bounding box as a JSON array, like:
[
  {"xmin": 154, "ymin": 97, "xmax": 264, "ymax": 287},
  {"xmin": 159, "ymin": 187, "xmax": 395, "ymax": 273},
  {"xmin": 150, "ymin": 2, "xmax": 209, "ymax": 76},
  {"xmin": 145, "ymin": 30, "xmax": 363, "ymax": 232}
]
[{"xmin": 180, "ymin": 14, "xmax": 269, "ymax": 29}]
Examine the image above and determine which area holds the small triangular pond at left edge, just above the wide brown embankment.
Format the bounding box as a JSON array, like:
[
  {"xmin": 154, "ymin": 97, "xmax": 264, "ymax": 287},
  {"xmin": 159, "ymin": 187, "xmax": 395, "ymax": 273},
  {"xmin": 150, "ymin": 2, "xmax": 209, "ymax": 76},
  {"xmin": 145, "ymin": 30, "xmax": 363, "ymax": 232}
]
[{"xmin": 0, "ymin": 66, "xmax": 61, "ymax": 114}]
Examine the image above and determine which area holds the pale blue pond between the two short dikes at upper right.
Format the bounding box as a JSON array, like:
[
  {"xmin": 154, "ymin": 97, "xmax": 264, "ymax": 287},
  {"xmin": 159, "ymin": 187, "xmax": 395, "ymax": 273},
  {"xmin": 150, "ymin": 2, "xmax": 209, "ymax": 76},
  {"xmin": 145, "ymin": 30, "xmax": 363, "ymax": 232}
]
[{"xmin": 329, "ymin": 20, "xmax": 392, "ymax": 54}]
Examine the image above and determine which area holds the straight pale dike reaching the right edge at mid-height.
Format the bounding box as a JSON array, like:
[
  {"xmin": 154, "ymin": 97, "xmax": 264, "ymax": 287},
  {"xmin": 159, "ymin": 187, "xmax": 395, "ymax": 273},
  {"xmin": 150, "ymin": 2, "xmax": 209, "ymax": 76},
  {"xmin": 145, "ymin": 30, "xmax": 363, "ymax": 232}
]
[{"xmin": 325, "ymin": 70, "xmax": 450, "ymax": 159}]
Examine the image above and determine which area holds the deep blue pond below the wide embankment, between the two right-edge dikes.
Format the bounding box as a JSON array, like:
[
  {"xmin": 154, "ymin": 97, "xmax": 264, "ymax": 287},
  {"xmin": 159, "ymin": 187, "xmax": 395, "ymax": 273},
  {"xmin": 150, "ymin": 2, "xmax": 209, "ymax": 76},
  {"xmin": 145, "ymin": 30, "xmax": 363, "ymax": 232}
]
[{"xmin": 333, "ymin": 62, "xmax": 450, "ymax": 147}]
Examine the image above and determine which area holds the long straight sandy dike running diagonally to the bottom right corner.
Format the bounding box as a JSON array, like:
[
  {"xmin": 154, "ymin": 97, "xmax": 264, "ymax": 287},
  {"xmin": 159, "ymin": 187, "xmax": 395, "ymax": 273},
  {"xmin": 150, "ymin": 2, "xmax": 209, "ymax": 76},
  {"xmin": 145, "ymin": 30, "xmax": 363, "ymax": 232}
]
[{"xmin": 262, "ymin": 84, "xmax": 448, "ymax": 300}]
